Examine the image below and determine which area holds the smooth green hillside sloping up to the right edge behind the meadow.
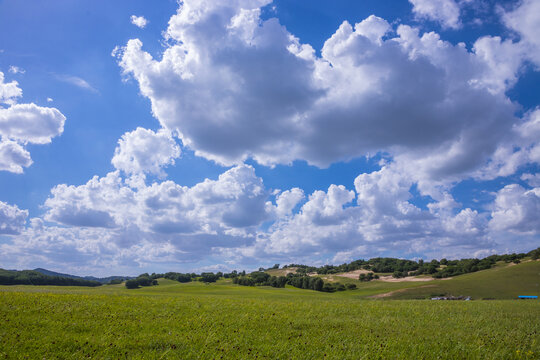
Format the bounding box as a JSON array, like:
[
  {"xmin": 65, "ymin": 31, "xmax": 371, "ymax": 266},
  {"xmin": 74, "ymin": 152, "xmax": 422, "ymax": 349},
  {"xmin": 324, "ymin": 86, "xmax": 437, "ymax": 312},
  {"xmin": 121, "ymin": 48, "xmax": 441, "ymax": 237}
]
[{"xmin": 390, "ymin": 261, "xmax": 540, "ymax": 299}]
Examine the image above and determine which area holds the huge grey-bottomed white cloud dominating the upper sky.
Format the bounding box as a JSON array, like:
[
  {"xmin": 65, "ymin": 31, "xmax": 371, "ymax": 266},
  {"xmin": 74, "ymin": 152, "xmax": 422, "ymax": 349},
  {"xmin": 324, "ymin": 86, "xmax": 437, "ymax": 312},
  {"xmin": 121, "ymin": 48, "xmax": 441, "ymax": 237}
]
[{"xmin": 119, "ymin": 0, "xmax": 516, "ymax": 193}]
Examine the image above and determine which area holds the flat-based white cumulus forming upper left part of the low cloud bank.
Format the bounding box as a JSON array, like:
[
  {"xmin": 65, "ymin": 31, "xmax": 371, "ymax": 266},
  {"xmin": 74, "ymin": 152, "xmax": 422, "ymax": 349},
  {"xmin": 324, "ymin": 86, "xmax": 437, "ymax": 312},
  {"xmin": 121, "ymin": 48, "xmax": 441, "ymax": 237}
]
[{"xmin": 45, "ymin": 165, "xmax": 269, "ymax": 237}]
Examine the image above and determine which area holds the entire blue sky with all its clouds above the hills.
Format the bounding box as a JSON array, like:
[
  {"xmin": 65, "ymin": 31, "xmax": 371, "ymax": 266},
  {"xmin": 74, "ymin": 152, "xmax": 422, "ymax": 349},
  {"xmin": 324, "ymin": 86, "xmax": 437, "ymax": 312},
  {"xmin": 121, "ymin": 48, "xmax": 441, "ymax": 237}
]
[{"xmin": 0, "ymin": 0, "xmax": 540, "ymax": 276}]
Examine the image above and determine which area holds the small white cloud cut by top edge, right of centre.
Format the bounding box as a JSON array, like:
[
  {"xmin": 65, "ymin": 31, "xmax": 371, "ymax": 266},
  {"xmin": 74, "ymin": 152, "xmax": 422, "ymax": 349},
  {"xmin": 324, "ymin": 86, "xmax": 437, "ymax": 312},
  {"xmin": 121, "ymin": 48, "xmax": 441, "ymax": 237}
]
[{"xmin": 409, "ymin": 0, "xmax": 461, "ymax": 29}]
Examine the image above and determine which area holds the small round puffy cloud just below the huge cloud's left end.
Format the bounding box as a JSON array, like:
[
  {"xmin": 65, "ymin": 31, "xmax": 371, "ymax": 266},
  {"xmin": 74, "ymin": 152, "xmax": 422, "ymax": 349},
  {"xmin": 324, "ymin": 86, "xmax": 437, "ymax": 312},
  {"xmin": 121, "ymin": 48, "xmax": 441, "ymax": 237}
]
[{"xmin": 111, "ymin": 127, "xmax": 180, "ymax": 177}]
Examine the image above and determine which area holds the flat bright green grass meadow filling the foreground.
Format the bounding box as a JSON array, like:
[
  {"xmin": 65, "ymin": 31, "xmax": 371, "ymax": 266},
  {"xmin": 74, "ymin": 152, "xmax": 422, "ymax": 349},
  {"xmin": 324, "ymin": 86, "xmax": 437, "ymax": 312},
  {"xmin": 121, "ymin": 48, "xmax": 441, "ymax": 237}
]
[{"xmin": 0, "ymin": 278, "xmax": 540, "ymax": 359}]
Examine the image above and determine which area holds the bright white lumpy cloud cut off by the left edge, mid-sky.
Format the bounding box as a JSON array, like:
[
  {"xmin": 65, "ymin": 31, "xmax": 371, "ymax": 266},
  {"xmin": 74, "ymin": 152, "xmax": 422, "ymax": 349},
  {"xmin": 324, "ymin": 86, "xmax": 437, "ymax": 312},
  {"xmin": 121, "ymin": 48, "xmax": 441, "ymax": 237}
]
[{"xmin": 0, "ymin": 72, "xmax": 66, "ymax": 174}]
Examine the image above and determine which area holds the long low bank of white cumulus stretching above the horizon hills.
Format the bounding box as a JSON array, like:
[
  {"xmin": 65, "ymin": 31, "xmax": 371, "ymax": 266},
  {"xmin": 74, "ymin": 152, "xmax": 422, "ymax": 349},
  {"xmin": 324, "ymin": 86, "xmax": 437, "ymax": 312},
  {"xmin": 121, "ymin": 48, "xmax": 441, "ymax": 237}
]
[{"xmin": 0, "ymin": 158, "xmax": 539, "ymax": 267}]
